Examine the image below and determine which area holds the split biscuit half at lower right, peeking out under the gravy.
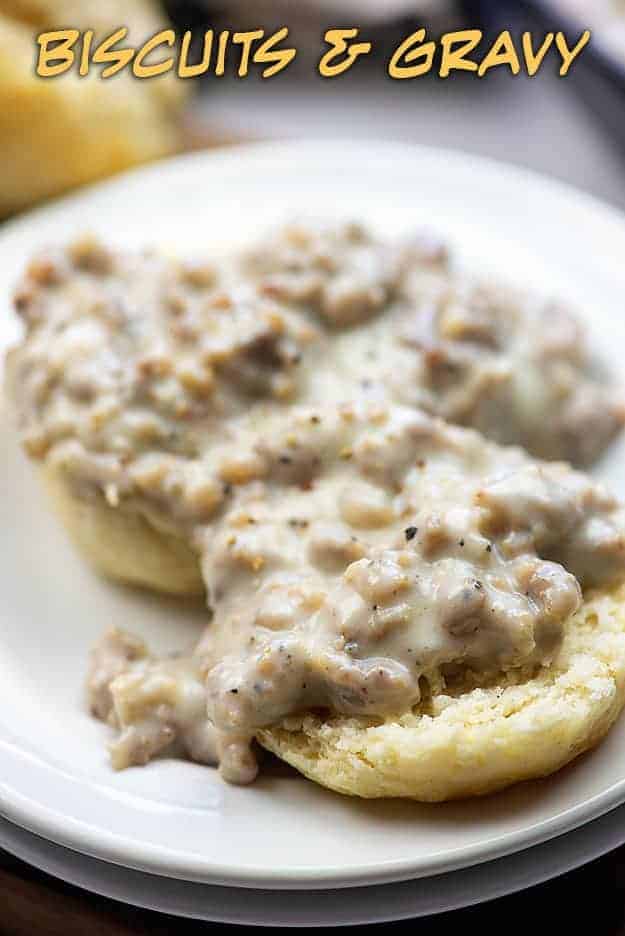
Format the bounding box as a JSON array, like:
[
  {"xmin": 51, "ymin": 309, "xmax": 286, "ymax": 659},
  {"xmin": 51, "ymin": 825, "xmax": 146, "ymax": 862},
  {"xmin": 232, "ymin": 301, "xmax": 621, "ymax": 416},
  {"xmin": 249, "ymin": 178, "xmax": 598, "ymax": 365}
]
[{"xmin": 257, "ymin": 587, "xmax": 625, "ymax": 802}]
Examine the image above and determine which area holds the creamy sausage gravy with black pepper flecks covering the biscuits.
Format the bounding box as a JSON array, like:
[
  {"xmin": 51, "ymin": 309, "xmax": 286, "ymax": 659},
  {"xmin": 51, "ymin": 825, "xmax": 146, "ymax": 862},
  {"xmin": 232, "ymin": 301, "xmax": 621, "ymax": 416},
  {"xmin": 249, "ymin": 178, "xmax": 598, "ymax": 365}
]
[{"xmin": 10, "ymin": 225, "xmax": 625, "ymax": 782}]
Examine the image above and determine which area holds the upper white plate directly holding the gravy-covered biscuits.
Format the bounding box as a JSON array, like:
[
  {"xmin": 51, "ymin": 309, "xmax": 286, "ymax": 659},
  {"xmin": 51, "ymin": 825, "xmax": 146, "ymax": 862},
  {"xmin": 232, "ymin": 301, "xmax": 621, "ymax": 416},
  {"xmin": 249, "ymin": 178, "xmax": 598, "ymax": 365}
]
[{"xmin": 0, "ymin": 142, "xmax": 625, "ymax": 889}]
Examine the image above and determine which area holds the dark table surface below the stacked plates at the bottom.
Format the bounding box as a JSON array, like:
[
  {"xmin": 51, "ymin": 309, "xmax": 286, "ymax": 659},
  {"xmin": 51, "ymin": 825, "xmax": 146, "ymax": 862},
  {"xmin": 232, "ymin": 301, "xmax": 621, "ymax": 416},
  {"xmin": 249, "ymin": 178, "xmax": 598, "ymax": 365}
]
[{"xmin": 0, "ymin": 847, "xmax": 625, "ymax": 936}]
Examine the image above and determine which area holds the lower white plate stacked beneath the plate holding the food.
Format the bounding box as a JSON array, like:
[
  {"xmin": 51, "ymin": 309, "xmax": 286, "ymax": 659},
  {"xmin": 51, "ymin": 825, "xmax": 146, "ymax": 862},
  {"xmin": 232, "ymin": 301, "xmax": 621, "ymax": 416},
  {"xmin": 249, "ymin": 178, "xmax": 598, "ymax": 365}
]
[{"xmin": 0, "ymin": 807, "xmax": 625, "ymax": 927}]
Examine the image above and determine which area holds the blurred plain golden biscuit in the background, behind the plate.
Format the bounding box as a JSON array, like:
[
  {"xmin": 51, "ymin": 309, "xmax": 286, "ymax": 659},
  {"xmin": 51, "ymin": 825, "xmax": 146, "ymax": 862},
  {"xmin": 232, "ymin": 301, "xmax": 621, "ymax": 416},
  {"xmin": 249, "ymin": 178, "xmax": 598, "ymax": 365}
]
[{"xmin": 0, "ymin": 0, "xmax": 186, "ymax": 216}]
